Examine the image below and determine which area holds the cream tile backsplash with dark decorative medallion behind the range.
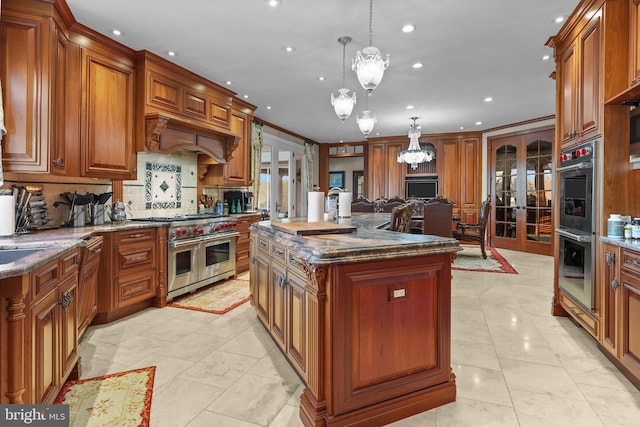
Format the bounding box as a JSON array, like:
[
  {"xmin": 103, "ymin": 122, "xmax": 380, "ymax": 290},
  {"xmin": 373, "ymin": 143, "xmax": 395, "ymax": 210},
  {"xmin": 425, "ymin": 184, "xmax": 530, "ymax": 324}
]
[{"xmin": 123, "ymin": 152, "xmax": 198, "ymax": 218}]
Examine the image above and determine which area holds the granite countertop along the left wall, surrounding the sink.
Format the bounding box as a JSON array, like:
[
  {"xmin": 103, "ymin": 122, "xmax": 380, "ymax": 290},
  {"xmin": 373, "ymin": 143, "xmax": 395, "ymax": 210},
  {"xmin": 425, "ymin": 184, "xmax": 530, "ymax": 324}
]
[{"xmin": 0, "ymin": 221, "xmax": 167, "ymax": 279}]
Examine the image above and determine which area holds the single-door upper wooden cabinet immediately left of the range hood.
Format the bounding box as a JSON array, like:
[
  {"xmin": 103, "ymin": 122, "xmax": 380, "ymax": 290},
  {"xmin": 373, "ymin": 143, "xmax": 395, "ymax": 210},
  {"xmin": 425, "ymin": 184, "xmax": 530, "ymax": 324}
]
[{"xmin": 80, "ymin": 48, "xmax": 136, "ymax": 179}]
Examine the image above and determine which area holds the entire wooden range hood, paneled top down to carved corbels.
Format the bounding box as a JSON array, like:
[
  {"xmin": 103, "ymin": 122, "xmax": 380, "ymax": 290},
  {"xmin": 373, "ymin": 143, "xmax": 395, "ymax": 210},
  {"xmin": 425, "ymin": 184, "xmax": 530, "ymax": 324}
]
[{"xmin": 136, "ymin": 51, "xmax": 255, "ymax": 169}]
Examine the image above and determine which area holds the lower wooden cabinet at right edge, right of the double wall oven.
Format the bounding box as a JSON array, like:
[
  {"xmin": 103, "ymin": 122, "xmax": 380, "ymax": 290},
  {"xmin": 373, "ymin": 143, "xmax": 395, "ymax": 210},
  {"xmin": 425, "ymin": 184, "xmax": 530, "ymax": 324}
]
[{"xmin": 600, "ymin": 244, "xmax": 640, "ymax": 388}]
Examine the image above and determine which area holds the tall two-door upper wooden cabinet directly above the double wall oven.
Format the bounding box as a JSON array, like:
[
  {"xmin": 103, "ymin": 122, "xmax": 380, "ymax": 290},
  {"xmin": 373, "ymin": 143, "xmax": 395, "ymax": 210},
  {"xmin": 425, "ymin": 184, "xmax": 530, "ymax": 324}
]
[{"xmin": 558, "ymin": 6, "xmax": 603, "ymax": 147}]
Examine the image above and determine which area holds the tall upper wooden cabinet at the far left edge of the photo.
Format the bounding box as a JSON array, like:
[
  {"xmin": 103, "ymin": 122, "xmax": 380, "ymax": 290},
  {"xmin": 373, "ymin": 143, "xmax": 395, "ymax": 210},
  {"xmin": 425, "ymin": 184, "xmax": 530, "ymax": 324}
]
[{"xmin": 0, "ymin": 0, "xmax": 66, "ymax": 173}]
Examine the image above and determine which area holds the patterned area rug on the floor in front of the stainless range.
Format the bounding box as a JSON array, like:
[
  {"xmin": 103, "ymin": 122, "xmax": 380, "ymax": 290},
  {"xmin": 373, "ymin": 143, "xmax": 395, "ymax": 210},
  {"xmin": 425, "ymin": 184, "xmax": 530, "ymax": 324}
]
[{"xmin": 168, "ymin": 279, "xmax": 251, "ymax": 314}]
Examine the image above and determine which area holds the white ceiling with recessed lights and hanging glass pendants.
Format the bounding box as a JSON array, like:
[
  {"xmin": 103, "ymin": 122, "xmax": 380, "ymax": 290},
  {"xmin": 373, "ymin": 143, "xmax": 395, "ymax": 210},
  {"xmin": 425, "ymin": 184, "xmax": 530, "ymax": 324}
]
[{"xmin": 67, "ymin": 0, "xmax": 579, "ymax": 142}]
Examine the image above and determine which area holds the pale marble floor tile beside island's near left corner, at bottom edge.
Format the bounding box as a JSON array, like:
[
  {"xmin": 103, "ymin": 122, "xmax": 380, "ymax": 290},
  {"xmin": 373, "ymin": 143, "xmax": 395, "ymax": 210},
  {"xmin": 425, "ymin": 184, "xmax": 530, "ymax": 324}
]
[{"xmin": 207, "ymin": 374, "xmax": 298, "ymax": 426}]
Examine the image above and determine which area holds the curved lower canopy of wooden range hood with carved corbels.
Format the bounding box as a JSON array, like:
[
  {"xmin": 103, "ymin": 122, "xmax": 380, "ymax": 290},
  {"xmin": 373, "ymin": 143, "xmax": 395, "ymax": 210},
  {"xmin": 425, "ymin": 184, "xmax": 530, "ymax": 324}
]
[{"xmin": 145, "ymin": 113, "xmax": 240, "ymax": 163}]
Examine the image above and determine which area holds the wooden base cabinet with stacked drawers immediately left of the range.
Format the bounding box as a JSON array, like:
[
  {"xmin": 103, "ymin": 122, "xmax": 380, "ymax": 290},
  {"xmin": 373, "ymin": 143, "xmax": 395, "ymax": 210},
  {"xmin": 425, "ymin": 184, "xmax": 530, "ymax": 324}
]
[{"xmin": 94, "ymin": 227, "xmax": 166, "ymax": 323}]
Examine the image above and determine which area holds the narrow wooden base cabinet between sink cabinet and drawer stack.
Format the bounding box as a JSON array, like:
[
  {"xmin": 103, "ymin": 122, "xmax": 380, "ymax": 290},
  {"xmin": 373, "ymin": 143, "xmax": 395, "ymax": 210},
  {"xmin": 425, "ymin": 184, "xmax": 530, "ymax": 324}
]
[{"xmin": 78, "ymin": 236, "xmax": 104, "ymax": 336}]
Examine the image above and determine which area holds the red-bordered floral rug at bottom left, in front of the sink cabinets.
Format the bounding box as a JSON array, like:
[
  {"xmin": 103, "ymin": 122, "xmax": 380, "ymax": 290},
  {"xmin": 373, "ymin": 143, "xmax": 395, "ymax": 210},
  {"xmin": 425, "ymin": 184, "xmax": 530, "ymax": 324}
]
[{"xmin": 54, "ymin": 366, "xmax": 156, "ymax": 427}]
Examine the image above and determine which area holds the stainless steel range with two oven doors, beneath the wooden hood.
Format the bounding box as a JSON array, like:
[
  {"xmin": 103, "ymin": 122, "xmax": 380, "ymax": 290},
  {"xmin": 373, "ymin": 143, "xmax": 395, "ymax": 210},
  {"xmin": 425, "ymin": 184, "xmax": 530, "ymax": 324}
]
[{"xmin": 140, "ymin": 215, "xmax": 239, "ymax": 301}]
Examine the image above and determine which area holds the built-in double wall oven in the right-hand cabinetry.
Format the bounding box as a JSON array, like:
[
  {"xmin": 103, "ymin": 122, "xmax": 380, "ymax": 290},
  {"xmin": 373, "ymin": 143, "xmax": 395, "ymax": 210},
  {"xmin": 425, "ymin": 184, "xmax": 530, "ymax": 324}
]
[{"xmin": 556, "ymin": 140, "xmax": 599, "ymax": 311}]
